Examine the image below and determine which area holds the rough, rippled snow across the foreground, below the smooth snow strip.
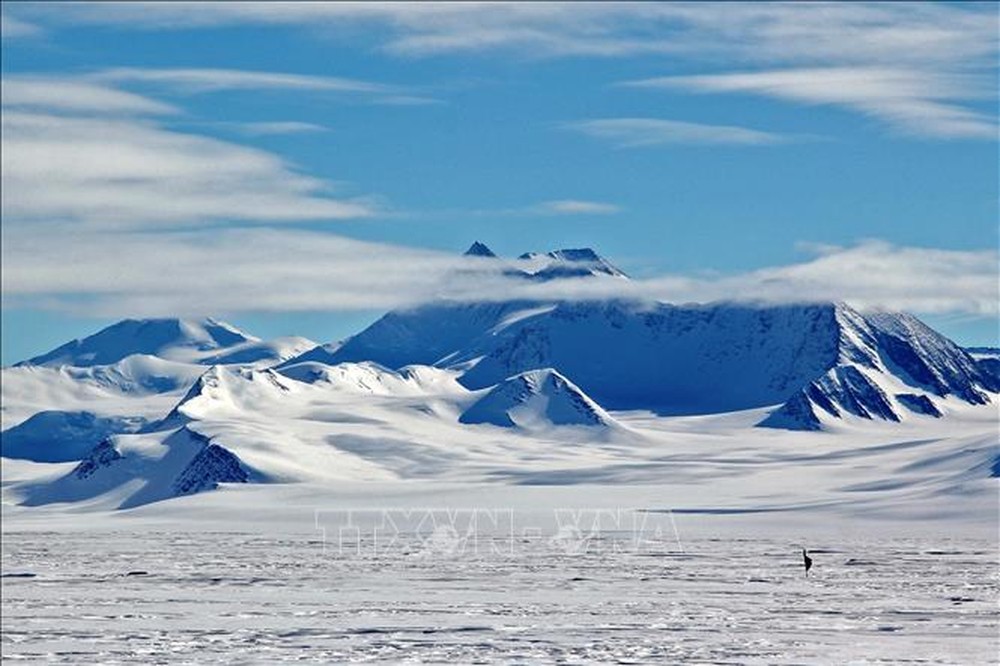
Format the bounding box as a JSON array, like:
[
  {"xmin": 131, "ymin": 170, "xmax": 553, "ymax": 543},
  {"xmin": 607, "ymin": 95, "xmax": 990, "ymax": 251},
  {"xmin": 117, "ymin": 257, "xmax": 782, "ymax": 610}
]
[{"xmin": 0, "ymin": 511, "xmax": 998, "ymax": 666}]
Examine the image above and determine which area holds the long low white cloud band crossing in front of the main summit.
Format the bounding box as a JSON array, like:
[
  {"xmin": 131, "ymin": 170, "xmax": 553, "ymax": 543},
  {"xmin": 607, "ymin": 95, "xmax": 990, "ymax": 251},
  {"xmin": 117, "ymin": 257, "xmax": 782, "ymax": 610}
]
[{"xmin": 2, "ymin": 228, "xmax": 998, "ymax": 316}]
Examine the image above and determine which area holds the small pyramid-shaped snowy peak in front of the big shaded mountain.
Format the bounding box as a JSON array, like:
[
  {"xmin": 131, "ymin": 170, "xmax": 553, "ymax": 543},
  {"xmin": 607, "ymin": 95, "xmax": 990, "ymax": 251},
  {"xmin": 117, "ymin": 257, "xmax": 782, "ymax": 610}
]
[{"xmin": 459, "ymin": 368, "xmax": 616, "ymax": 429}]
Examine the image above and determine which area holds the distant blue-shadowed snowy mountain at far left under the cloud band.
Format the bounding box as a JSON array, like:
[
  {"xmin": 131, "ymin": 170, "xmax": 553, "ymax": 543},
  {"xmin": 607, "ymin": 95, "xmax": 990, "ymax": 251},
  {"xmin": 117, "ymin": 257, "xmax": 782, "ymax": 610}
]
[{"xmin": 18, "ymin": 319, "xmax": 257, "ymax": 367}]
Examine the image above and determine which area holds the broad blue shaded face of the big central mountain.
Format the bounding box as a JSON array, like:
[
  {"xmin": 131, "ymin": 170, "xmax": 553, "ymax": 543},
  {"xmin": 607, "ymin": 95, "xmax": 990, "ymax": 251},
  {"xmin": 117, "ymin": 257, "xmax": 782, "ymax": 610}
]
[{"xmin": 454, "ymin": 301, "xmax": 837, "ymax": 414}]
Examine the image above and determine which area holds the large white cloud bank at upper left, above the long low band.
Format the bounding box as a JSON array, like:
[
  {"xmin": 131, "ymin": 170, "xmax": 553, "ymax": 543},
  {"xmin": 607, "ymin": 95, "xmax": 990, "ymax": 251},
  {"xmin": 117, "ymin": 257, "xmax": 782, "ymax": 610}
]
[{"xmin": 0, "ymin": 78, "xmax": 379, "ymax": 228}]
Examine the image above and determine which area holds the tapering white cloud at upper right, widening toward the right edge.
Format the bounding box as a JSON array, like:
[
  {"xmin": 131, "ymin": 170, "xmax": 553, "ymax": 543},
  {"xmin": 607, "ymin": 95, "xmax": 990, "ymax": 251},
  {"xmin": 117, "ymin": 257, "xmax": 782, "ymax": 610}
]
[{"xmin": 626, "ymin": 67, "xmax": 998, "ymax": 139}]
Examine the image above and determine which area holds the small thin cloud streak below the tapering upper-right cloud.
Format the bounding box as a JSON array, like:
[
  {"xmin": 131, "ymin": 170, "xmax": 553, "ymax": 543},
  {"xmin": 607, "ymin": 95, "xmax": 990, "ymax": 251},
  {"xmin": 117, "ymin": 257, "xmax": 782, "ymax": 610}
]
[{"xmin": 564, "ymin": 118, "xmax": 786, "ymax": 148}]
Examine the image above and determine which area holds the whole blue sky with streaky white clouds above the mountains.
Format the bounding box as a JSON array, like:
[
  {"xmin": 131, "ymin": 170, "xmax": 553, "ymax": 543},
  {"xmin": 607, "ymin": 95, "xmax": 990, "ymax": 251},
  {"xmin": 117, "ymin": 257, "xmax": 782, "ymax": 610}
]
[{"xmin": 2, "ymin": 3, "xmax": 1000, "ymax": 363}]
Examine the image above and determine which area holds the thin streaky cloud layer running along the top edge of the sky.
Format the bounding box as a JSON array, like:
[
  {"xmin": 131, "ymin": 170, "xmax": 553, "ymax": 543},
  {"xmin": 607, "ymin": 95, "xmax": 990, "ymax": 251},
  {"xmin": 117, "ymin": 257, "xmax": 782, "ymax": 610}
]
[{"xmin": 26, "ymin": 2, "xmax": 997, "ymax": 64}]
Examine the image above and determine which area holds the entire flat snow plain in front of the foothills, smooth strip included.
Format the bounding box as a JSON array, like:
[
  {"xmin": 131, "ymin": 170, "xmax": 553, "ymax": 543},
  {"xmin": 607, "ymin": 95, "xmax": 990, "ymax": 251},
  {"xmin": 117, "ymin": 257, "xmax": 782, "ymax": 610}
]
[{"xmin": 2, "ymin": 483, "xmax": 1000, "ymax": 664}]
